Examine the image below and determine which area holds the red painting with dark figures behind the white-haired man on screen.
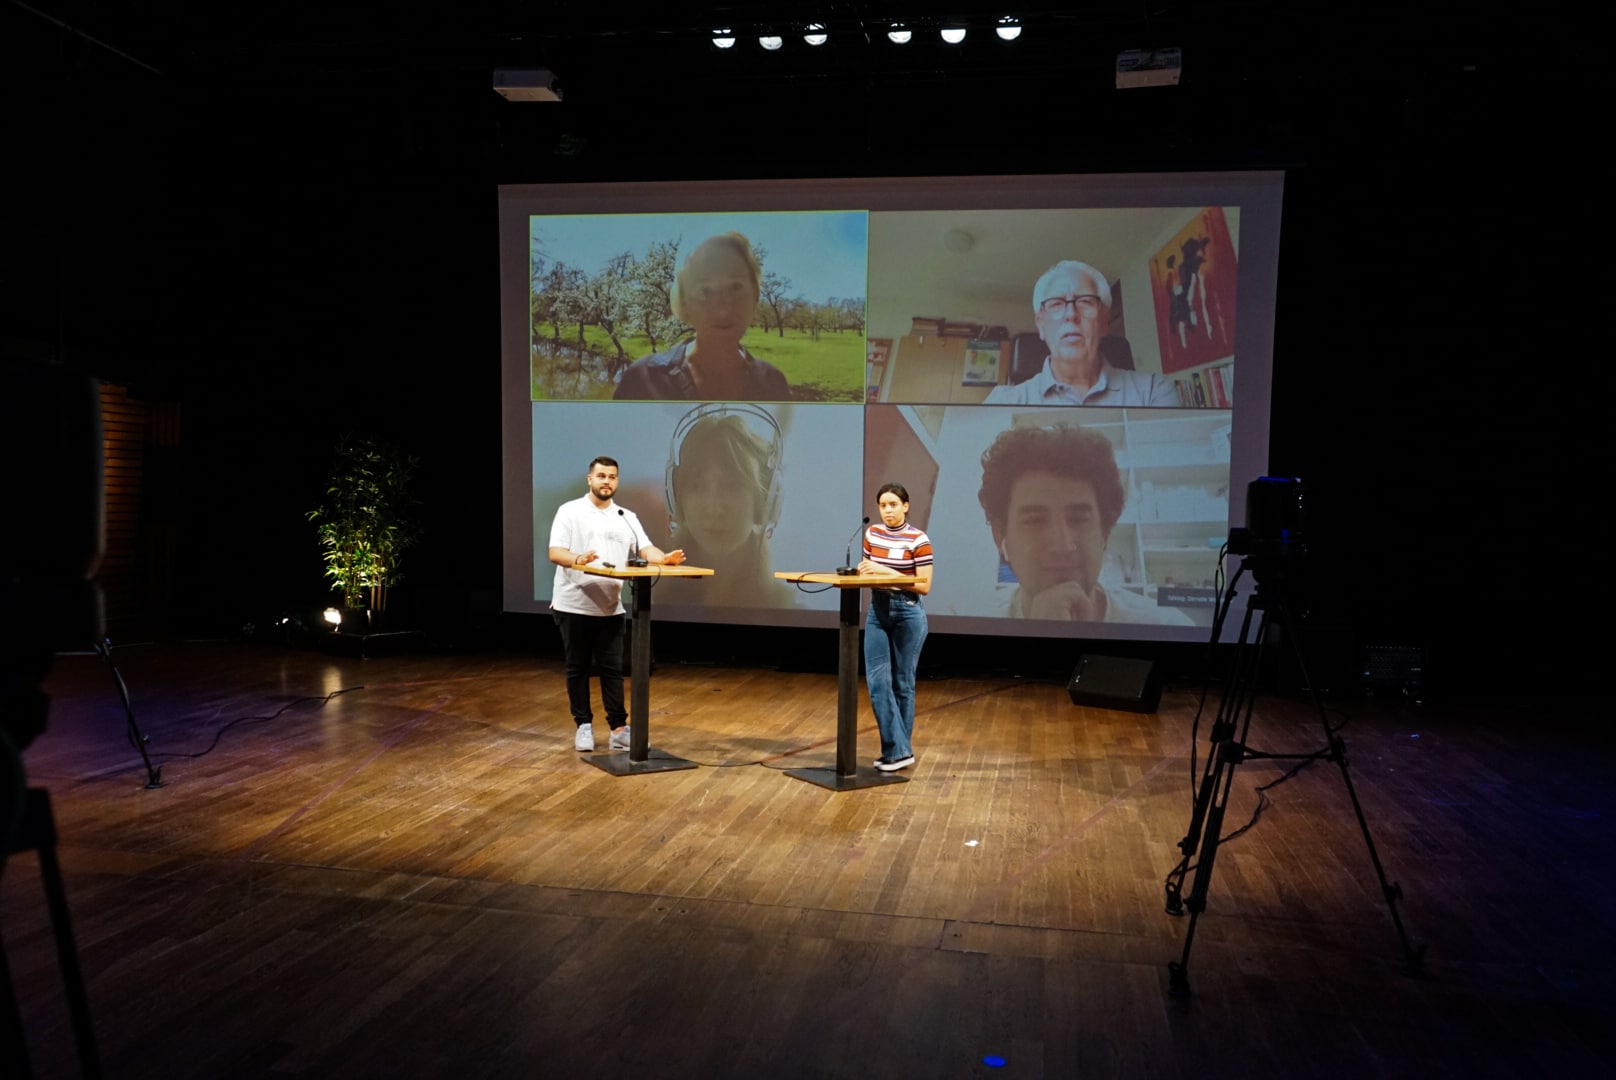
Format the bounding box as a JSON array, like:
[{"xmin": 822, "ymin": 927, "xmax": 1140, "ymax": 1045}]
[{"xmin": 1151, "ymin": 207, "xmax": 1236, "ymax": 372}]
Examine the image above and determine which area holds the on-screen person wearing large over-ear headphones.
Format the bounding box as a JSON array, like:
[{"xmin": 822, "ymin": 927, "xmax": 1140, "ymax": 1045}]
[{"xmin": 664, "ymin": 403, "xmax": 797, "ymax": 608}]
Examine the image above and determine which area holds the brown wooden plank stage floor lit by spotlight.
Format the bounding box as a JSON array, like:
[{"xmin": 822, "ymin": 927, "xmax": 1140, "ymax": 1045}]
[{"xmin": 0, "ymin": 642, "xmax": 1616, "ymax": 1080}]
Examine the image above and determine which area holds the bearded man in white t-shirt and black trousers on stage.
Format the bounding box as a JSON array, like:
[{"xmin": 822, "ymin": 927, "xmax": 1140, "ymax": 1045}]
[{"xmin": 549, "ymin": 456, "xmax": 685, "ymax": 750}]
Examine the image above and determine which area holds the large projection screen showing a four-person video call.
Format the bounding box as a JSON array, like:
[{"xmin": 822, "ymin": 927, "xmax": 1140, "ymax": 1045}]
[{"xmin": 499, "ymin": 173, "xmax": 1283, "ymax": 640}]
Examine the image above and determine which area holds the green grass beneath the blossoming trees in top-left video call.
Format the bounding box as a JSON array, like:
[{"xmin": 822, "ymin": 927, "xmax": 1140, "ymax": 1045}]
[{"xmin": 532, "ymin": 323, "xmax": 865, "ymax": 403}]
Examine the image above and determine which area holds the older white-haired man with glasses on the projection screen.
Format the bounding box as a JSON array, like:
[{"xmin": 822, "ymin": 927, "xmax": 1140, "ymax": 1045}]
[{"xmin": 983, "ymin": 259, "xmax": 1178, "ymax": 407}]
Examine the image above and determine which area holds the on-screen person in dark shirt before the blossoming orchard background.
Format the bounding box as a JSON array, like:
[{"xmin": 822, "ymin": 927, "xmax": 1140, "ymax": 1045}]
[{"xmin": 612, "ymin": 233, "xmax": 792, "ymax": 401}]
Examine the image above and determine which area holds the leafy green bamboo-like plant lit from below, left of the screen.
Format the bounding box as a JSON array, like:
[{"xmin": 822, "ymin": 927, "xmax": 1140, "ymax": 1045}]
[{"xmin": 309, "ymin": 435, "xmax": 420, "ymax": 631}]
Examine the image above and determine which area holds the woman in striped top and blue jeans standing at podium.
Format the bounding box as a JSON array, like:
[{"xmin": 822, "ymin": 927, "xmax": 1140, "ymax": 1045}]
[{"xmin": 858, "ymin": 483, "xmax": 931, "ymax": 773}]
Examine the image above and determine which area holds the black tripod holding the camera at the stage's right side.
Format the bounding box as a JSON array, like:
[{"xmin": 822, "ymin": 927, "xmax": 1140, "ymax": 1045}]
[{"xmin": 1167, "ymin": 555, "xmax": 1425, "ymax": 996}]
